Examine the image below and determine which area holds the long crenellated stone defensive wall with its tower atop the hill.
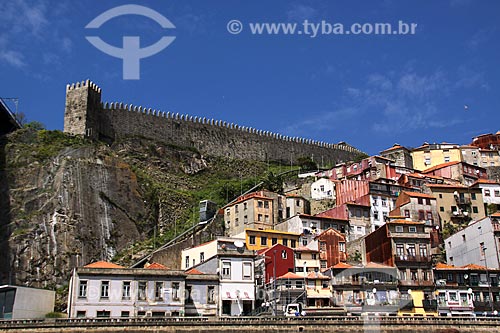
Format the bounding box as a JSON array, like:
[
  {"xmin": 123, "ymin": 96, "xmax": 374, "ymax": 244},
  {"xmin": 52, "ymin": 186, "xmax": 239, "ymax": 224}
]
[{"xmin": 65, "ymin": 80, "xmax": 362, "ymax": 164}]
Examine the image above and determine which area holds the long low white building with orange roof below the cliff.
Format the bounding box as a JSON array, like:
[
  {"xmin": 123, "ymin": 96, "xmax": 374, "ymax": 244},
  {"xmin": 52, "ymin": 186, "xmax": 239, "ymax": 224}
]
[{"xmin": 68, "ymin": 262, "xmax": 191, "ymax": 318}]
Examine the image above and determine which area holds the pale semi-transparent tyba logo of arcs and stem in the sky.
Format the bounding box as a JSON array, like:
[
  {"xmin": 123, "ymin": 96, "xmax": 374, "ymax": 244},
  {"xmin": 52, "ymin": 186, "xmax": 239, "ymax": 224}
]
[{"xmin": 85, "ymin": 5, "xmax": 175, "ymax": 80}]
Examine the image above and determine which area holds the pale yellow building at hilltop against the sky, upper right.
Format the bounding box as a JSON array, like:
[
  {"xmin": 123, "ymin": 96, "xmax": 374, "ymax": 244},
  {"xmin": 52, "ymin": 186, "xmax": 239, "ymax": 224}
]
[{"xmin": 411, "ymin": 142, "xmax": 462, "ymax": 171}]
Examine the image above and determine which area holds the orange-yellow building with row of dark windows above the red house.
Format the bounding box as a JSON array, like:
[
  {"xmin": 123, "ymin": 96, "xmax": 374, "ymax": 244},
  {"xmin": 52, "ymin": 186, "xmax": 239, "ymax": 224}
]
[{"xmin": 240, "ymin": 229, "xmax": 300, "ymax": 251}]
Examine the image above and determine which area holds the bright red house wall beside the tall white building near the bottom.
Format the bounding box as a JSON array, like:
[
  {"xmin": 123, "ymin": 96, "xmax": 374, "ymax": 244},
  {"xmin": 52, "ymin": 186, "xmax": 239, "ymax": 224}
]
[{"xmin": 257, "ymin": 244, "xmax": 295, "ymax": 284}]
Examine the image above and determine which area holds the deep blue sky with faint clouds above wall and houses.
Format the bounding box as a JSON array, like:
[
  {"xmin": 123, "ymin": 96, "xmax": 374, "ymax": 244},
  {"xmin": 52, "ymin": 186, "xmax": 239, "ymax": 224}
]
[{"xmin": 0, "ymin": 0, "xmax": 500, "ymax": 154}]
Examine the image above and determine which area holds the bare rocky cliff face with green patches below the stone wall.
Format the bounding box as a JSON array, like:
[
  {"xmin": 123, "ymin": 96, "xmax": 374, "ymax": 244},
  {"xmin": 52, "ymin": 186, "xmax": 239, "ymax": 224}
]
[{"xmin": 0, "ymin": 129, "xmax": 265, "ymax": 308}]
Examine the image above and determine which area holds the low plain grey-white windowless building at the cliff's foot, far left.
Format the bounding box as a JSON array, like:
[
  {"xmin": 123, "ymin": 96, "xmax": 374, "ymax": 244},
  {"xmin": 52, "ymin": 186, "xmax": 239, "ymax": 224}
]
[{"xmin": 0, "ymin": 285, "xmax": 56, "ymax": 319}]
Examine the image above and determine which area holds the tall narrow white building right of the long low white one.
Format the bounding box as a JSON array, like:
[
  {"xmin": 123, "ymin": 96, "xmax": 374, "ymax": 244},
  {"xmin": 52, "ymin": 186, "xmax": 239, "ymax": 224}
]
[{"xmin": 182, "ymin": 237, "xmax": 256, "ymax": 316}]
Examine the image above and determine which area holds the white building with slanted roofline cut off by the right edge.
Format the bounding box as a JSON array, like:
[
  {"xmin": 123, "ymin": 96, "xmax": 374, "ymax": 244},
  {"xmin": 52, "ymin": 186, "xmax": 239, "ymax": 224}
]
[{"xmin": 444, "ymin": 213, "xmax": 500, "ymax": 268}]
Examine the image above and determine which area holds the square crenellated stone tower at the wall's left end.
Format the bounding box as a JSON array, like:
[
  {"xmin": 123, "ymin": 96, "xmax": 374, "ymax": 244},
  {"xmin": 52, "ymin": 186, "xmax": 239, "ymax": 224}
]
[{"xmin": 64, "ymin": 80, "xmax": 102, "ymax": 139}]
